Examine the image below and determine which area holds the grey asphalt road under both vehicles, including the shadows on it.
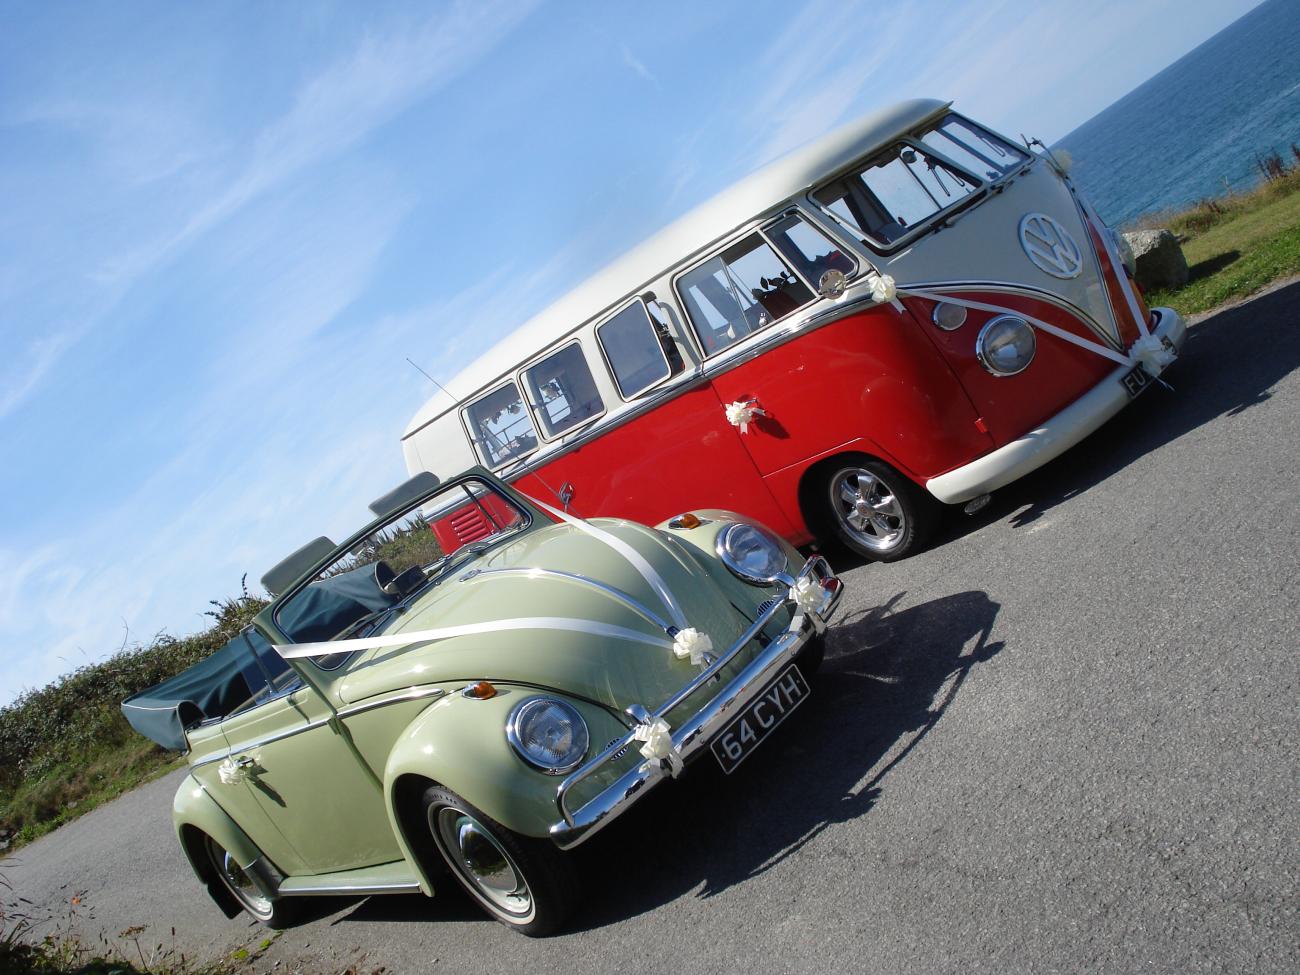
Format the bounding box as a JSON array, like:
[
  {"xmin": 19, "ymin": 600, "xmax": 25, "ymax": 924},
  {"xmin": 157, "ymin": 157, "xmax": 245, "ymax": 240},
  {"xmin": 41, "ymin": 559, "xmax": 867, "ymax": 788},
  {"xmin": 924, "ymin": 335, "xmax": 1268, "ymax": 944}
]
[{"xmin": 8, "ymin": 283, "xmax": 1300, "ymax": 975}]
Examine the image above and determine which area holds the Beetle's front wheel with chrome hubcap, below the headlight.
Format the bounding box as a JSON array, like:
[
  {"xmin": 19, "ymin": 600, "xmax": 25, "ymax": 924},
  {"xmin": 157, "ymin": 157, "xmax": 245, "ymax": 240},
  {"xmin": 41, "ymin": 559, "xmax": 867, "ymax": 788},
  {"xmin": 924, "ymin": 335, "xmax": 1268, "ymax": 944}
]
[{"xmin": 424, "ymin": 785, "xmax": 577, "ymax": 937}]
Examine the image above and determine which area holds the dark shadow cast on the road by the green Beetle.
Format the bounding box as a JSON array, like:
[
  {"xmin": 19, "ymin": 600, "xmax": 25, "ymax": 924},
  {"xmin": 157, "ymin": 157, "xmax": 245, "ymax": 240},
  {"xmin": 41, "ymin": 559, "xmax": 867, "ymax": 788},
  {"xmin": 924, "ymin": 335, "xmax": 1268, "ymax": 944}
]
[{"xmin": 564, "ymin": 592, "xmax": 1002, "ymax": 930}]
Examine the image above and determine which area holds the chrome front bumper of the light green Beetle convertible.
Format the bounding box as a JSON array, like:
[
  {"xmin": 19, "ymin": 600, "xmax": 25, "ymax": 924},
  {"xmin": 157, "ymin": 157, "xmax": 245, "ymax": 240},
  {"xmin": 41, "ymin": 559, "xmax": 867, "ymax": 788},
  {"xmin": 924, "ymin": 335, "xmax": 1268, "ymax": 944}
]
[{"xmin": 550, "ymin": 555, "xmax": 842, "ymax": 849}]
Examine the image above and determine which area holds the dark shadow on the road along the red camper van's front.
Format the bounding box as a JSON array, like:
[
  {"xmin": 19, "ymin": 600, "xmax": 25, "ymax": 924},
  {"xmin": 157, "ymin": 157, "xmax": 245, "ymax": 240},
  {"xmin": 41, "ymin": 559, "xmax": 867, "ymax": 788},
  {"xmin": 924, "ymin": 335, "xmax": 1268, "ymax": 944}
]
[{"xmin": 931, "ymin": 282, "xmax": 1300, "ymax": 547}]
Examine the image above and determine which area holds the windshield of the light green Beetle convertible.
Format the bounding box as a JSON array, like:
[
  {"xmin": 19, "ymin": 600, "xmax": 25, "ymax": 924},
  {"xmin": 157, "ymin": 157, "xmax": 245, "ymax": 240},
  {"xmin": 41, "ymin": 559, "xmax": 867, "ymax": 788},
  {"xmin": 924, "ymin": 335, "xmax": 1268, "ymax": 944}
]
[{"xmin": 274, "ymin": 478, "xmax": 529, "ymax": 670}]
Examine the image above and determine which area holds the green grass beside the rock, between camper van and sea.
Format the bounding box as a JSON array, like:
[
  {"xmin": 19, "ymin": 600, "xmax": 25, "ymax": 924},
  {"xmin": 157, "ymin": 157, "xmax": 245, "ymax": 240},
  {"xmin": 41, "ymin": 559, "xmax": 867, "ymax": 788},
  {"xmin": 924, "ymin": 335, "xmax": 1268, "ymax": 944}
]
[{"xmin": 1139, "ymin": 166, "xmax": 1300, "ymax": 317}]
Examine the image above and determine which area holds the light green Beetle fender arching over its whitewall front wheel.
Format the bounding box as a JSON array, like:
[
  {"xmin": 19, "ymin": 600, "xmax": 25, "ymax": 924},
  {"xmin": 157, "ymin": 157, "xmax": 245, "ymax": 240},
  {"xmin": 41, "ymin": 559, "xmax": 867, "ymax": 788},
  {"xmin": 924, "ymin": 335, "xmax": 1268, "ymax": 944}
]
[{"xmin": 384, "ymin": 681, "xmax": 627, "ymax": 893}]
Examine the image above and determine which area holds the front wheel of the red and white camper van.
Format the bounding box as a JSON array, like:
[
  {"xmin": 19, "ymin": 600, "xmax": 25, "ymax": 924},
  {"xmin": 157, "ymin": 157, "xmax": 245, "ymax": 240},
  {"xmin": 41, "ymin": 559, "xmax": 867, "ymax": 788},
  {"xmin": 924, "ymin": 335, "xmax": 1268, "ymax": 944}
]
[{"xmin": 823, "ymin": 458, "xmax": 935, "ymax": 562}]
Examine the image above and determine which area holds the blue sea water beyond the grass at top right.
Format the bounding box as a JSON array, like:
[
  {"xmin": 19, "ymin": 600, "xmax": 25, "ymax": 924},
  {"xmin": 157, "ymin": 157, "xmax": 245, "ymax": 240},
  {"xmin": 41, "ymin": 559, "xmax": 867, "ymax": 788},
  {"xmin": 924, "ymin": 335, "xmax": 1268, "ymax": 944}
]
[{"xmin": 1057, "ymin": 0, "xmax": 1300, "ymax": 225}]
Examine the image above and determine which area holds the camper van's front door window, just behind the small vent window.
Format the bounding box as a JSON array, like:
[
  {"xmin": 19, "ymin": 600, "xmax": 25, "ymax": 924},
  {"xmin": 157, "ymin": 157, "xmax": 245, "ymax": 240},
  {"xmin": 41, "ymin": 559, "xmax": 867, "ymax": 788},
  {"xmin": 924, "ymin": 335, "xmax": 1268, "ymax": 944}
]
[{"xmin": 677, "ymin": 233, "xmax": 814, "ymax": 355}]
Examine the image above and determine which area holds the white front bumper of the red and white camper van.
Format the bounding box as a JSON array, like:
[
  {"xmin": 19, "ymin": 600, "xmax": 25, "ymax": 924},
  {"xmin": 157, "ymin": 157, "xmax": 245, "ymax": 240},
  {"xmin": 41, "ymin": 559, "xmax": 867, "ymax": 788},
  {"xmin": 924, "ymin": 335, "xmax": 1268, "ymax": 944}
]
[{"xmin": 926, "ymin": 308, "xmax": 1187, "ymax": 504}]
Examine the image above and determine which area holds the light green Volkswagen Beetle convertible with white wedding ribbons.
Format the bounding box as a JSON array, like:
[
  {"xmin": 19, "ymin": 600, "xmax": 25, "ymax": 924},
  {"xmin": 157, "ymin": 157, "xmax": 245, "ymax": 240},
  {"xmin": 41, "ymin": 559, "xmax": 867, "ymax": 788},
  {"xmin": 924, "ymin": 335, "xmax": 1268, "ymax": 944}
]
[{"xmin": 122, "ymin": 469, "xmax": 840, "ymax": 935}]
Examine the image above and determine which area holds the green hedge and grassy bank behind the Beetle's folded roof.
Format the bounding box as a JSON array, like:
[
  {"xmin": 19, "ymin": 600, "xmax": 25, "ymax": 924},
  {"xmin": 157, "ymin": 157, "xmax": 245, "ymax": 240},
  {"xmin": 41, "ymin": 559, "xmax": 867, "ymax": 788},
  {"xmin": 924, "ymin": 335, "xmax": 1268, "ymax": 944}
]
[{"xmin": 0, "ymin": 589, "xmax": 265, "ymax": 852}]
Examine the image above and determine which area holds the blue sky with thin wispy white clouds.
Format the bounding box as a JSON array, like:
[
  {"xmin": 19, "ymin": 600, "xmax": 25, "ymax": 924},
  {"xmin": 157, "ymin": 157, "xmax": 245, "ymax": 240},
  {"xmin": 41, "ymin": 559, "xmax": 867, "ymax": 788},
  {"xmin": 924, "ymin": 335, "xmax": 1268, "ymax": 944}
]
[{"xmin": 0, "ymin": 0, "xmax": 1255, "ymax": 703}]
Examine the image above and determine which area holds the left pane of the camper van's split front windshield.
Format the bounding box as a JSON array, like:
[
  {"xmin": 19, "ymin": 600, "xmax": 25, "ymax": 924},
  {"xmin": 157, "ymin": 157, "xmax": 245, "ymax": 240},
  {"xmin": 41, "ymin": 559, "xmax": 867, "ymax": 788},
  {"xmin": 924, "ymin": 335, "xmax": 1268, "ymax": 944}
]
[{"xmin": 813, "ymin": 142, "xmax": 979, "ymax": 247}]
